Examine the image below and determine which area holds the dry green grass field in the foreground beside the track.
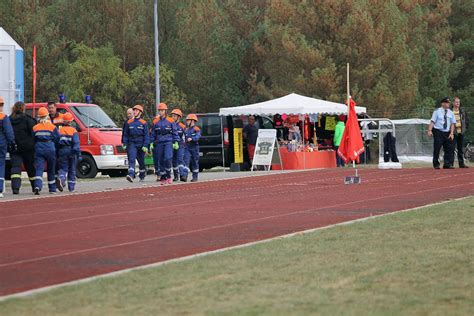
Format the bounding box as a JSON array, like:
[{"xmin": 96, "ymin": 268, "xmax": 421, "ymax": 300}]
[{"xmin": 0, "ymin": 197, "xmax": 474, "ymax": 315}]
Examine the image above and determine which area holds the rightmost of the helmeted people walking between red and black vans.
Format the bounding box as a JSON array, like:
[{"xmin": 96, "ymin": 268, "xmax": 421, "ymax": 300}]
[{"xmin": 181, "ymin": 114, "xmax": 201, "ymax": 182}]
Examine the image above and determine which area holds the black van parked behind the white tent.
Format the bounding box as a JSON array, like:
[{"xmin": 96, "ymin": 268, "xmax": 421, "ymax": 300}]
[{"xmin": 197, "ymin": 113, "xmax": 274, "ymax": 170}]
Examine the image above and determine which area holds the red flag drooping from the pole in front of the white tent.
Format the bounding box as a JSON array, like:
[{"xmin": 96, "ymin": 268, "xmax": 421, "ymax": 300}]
[{"xmin": 337, "ymin": 98, "xmax": 365, "ymax": 162}]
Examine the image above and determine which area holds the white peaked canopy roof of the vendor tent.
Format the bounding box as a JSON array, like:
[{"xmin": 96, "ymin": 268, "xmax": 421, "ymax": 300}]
[{"xmin": 219, "ymin": 93, "xmax": 366, "ymax": 116}]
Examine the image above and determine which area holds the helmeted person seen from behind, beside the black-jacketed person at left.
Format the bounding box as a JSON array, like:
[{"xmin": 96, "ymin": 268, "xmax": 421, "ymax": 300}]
[{"xmin": 33, "ymin": 108, "xmax": 59, "ymax": 195}]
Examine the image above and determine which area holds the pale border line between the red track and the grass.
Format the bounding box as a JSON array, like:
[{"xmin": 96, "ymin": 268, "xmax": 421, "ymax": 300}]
[{"xmin": 0, "ymin": 196, "xmax": 471, "ymax": 302}]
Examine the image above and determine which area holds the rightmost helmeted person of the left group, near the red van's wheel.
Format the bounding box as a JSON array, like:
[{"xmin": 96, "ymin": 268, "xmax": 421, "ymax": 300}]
[{"xmin": 56, "ymin": 113, "xmax": 81, "ymax": 192}]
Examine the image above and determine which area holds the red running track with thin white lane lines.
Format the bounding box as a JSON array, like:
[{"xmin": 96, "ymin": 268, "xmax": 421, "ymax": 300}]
[{"xmin": 0, "ymin": 168, "xmax": 474, "ymax": 296}]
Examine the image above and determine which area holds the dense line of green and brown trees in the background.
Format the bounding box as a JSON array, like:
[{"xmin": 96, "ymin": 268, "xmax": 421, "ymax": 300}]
[{"xmin": 0, "ymin": 0, "xmax": 474, "ymax": 131}]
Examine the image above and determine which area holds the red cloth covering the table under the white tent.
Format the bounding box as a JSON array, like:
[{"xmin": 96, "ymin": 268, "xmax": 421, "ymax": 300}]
[{"xmin": 272, "ymin": 147, "xmax": 336, "ymax": 170}]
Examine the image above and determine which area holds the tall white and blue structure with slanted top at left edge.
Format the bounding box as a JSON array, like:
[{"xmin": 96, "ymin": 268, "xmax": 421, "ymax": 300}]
[{"xmin": 0, "ymin": 27, "xmax": 25, "ymax": 114}]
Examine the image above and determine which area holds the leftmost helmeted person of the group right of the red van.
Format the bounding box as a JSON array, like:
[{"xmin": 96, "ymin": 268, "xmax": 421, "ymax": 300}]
[{"xmin": 122, "ymin": 105, "xmax": 150, "ymax": 182}]
